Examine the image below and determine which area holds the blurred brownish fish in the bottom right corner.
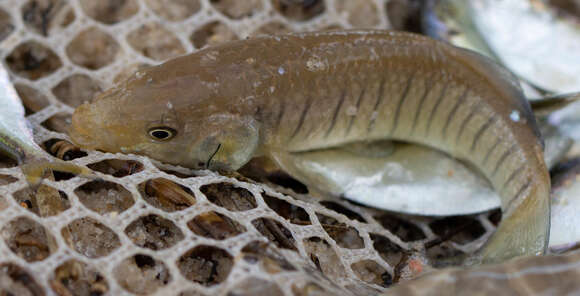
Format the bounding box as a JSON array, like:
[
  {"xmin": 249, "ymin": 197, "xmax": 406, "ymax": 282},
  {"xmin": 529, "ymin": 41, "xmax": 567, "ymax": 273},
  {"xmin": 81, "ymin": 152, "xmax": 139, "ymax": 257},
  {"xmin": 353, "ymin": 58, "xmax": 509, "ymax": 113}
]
[{"xmin": 388, "ymin": 251, "xmax": 580, "ymax": 296}]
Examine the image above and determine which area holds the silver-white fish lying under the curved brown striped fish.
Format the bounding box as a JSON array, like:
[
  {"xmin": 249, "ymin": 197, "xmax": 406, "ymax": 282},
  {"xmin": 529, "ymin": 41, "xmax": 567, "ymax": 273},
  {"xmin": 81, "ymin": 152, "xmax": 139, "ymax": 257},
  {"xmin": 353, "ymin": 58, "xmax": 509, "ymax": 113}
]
[{"xmin": 270, "ymin": 142, "xmax": 501, "ymax": 216}]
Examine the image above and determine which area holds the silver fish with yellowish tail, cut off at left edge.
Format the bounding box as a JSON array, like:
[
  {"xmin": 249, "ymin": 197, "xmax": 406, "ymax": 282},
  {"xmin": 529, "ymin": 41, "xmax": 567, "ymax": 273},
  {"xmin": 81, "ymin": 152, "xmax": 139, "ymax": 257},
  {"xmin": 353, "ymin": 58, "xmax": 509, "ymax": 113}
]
[{"xmin": 0, "ymin": 64, "xmax": 94, "ymax": 187}]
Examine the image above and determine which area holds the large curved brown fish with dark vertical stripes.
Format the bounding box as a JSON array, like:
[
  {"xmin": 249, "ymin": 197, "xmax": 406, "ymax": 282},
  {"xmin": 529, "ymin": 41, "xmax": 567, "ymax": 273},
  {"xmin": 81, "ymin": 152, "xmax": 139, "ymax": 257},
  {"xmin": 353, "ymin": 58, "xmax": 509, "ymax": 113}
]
[{"xmin": 69, "ymin": 30, "xmax": 550, "ymax": 264}]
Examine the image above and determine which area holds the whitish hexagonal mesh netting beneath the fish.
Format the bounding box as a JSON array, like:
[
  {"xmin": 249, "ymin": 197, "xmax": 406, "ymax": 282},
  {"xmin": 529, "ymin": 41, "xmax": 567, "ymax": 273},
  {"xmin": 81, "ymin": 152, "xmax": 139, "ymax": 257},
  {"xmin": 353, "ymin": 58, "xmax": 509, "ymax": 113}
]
[{"xmin": 0, "ymin": 0, "xmax": 500, "ymax": 295}]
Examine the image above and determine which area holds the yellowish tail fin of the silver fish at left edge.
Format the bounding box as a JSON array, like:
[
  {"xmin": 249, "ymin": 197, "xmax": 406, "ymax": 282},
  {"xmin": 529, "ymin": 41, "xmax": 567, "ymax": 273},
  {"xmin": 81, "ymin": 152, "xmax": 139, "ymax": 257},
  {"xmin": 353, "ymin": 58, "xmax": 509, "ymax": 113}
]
[{"xmin": 20, "ymin": 160, "xmax": 96, "ymax": 187}]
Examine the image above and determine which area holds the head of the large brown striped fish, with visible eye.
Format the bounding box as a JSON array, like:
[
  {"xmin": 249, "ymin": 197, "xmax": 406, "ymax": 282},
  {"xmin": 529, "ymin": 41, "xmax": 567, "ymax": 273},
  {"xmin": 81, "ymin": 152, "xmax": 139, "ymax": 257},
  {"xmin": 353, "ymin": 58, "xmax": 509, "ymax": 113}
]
[{"xmin": 69, "ymin": 65, "xmax": 259, "ymax": 170}]
